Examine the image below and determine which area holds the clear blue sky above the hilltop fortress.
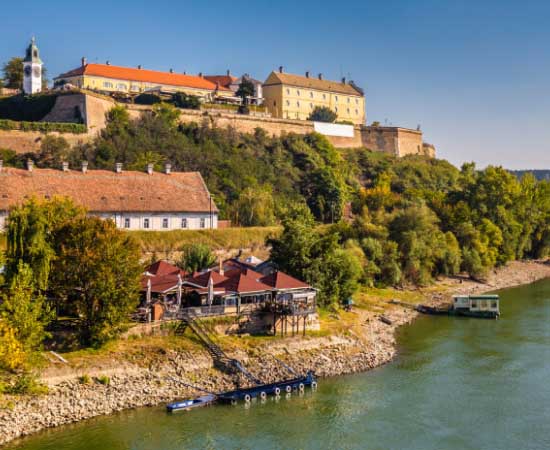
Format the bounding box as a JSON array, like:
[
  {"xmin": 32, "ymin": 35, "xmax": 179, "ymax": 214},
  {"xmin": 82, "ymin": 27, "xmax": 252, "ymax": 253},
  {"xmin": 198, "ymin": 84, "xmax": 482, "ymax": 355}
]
[{"xmin": 0, "ymin": 0, "xmax": 550, "ymax": 169}]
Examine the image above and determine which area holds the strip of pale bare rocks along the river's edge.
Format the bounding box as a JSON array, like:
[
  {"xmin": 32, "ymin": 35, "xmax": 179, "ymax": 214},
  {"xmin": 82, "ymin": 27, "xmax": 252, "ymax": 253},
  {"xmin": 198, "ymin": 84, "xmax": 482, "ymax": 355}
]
[{"xmin": 0, "ymin": 261, "xmax": 550, "ymax": 445}]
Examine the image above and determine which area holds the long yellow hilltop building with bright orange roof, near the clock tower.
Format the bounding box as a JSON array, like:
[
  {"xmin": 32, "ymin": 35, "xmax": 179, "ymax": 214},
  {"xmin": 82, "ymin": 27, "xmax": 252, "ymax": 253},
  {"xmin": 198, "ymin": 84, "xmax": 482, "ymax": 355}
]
[{"xmin": 54, "ymin": 58, "xmax": 234, "ymax": 100}]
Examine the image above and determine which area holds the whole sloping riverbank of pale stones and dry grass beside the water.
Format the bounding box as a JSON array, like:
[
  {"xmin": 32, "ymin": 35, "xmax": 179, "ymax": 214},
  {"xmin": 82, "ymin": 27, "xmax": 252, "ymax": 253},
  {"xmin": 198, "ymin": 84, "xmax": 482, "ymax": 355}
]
[{"xmin": 0, "ymin": 262, "xmax": 550, "ymax": 444}]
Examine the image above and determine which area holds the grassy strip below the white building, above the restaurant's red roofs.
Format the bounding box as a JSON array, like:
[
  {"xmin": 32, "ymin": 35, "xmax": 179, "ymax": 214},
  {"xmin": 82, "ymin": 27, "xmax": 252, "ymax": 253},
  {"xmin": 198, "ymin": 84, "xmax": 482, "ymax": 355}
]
[{"xmin": 128, "ymin": 227, "xmax": 281, "ymax": 253}]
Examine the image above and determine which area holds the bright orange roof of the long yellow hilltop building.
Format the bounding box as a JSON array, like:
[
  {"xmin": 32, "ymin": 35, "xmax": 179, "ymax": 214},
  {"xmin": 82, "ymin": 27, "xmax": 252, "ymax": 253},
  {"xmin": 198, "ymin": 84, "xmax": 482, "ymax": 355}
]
[{"xmin": 56, "ymin": 64, "xmax": 233, "ymax": 91}]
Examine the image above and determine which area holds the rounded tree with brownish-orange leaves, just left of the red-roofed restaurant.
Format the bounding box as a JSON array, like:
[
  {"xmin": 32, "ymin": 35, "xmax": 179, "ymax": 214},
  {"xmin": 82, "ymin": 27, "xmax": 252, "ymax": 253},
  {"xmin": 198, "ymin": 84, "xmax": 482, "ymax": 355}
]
[{"xmin": 52, "ymin": 217, "xmax": 142, "ymax": 346}]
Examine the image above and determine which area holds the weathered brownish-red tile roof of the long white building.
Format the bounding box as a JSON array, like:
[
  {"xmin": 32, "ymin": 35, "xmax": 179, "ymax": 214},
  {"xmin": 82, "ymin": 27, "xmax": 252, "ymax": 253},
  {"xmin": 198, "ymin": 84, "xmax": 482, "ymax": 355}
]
[{"xmin": 0, "ymin": 167, "xmax": 218, "ymax": 213}]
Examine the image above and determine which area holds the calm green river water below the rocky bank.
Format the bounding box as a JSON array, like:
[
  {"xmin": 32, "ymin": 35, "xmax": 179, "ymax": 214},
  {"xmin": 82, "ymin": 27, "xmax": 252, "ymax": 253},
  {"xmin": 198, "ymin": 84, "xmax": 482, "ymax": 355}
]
[{"xmin": 7, "ymin": 281, "xmax": 550, "ymax": 450}]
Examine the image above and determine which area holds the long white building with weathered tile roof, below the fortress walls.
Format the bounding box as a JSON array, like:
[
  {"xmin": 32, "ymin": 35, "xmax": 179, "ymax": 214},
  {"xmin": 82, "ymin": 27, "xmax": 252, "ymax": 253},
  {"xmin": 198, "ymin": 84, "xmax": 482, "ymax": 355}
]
[{"xmin": 0, "ymin": 161, "xmax": 218, "ymax": 231}]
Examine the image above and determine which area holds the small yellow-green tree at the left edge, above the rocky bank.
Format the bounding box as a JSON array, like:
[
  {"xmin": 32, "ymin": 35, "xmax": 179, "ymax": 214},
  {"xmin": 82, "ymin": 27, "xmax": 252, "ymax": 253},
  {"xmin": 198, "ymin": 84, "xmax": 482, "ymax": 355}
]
[{"xmin": 0, "ymin": 261, "xmax": 51, "ymax": 354}]
